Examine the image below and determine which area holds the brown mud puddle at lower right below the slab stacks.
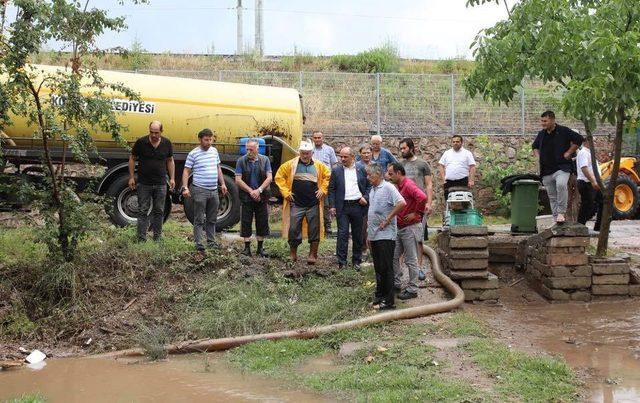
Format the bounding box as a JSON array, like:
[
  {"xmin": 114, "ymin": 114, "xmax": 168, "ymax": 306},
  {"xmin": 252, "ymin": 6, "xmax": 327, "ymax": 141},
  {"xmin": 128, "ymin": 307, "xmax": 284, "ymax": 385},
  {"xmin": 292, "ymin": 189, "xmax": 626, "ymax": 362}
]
[{"xmin": 470, "ymin": 297, "xmax": 640, "ymax": 403}]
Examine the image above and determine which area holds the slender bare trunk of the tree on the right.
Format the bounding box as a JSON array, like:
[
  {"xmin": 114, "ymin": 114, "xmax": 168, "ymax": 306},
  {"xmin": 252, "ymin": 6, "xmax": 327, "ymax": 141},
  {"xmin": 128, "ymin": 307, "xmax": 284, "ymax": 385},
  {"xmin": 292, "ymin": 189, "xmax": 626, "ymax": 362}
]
[{"xmin": 592, "ymin": 106, "xmax": 625, "ymax": 256}]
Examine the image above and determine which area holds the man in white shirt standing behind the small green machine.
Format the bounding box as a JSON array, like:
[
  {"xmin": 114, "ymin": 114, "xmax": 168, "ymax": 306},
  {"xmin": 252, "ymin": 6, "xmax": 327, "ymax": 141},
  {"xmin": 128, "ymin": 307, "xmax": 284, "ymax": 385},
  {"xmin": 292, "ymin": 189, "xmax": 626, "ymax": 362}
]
[{"xmin": 438, "ymin": 135, "xmax": 476, "ymax": 200}]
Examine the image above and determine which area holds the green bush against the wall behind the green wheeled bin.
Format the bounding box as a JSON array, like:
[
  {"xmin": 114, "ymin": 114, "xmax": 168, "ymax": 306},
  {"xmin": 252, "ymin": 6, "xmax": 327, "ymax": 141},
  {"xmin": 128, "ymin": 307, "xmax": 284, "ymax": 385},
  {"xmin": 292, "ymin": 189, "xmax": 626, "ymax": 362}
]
[{"xmin": 476, "ymin": 135, "xmax": 536, "ymax": 217}]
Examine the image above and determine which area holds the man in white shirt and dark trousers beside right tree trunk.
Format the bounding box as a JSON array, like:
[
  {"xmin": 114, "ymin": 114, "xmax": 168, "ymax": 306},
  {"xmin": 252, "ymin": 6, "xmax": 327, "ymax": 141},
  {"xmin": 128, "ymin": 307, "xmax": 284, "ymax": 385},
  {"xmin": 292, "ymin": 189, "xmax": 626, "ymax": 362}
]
[{"xmin": 576, "ymin": 141, "xmax": 602, "ymax": 231}]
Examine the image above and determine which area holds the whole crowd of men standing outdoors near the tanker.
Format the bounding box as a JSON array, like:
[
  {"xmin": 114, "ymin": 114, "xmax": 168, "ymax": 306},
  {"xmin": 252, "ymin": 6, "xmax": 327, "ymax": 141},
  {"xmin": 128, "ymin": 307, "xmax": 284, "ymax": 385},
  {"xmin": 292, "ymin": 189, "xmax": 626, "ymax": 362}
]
[{"xmin": 129, "ymin": 111, "xmax": 602, "ymax": 310}]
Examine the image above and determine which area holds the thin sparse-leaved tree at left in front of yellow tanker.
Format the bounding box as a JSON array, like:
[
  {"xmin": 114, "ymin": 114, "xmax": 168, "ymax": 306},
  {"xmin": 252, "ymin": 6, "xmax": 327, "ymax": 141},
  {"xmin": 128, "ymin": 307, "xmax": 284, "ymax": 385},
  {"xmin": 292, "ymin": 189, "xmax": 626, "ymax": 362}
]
[{"xmin": 0, "ymin": 0, "xmax": 138, "ymax": 262}]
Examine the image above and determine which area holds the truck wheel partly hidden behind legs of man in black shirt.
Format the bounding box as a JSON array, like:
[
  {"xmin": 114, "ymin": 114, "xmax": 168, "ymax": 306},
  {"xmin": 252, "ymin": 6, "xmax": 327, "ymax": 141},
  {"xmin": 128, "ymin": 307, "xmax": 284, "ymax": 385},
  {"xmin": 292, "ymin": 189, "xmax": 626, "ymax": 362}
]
[{"xmin": 105, "ymin": 175, "xmax": 171, "ymax": 227}]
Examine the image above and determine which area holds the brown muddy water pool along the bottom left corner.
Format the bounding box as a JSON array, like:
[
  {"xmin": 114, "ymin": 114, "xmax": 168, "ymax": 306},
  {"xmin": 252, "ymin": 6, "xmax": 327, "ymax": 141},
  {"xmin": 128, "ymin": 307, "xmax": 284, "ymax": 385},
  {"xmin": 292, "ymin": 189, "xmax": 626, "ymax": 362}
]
[{"xmin": 0, "ymin": 354, "xmax": 328, "ymax": 402}]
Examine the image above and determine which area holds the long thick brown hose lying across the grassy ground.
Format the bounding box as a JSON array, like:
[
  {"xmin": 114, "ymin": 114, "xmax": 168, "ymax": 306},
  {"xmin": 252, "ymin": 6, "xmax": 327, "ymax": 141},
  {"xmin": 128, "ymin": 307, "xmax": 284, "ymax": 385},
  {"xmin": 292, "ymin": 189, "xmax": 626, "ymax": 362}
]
[{"xmin": 93, "ymin": 245, "xmax": 464, "ymax": 358}]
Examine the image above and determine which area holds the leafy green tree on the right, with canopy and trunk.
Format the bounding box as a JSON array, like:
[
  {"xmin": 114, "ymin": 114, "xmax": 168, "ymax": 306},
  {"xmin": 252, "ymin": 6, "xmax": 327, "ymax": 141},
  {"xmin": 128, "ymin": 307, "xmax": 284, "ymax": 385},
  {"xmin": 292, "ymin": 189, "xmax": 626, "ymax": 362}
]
[{"xmin": 464, "ymin": 0, "xmax": 640, "ymax": 256}]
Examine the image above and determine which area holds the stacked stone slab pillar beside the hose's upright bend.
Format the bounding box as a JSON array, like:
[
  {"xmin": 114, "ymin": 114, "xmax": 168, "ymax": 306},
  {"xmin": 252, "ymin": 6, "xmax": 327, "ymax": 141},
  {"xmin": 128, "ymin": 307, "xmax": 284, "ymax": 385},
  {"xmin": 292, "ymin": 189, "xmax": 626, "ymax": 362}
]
[{"xmin": 438, "ymin": 226, "xmax": 499, "ymax": 301}]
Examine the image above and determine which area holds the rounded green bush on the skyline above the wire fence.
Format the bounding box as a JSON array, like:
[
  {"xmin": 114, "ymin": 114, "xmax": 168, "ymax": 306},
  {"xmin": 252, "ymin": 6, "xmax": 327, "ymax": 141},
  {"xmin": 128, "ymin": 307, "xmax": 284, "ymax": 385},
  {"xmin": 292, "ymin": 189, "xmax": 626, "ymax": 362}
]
[{"xmin": 331, "ymin": 43, "xmax": 400, "ymax": 73}]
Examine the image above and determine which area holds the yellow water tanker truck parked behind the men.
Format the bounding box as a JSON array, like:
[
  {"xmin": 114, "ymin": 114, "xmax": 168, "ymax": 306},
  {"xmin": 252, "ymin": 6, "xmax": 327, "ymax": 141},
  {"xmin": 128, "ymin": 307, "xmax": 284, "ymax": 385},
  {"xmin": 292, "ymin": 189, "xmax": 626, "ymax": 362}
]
[{"xmin": 3, "ymin": 66, "xmax": 304, "ymax": 229}]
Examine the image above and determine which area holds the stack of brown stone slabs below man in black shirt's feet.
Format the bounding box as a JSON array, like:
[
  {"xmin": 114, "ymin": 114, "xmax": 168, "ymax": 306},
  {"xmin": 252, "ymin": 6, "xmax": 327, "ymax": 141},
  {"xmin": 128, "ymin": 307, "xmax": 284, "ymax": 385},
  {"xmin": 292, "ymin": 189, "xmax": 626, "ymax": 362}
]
[{"xmin": 525, "ymin": 225, "xmax": 592, "ymax": 301}]
